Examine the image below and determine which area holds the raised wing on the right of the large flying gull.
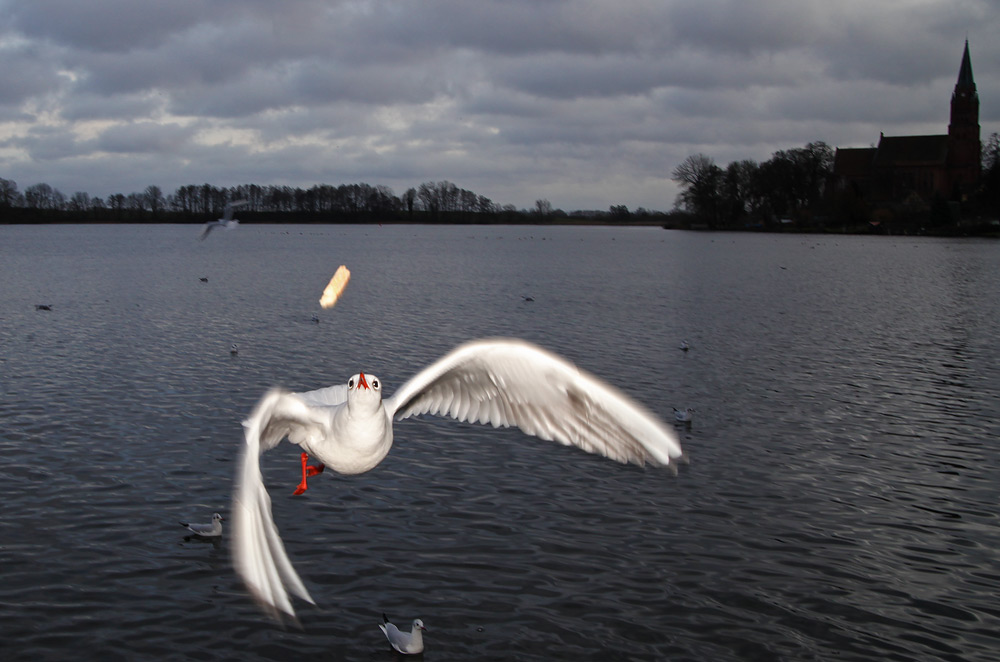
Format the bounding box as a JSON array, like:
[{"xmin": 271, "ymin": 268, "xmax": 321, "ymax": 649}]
[{"xmin": 385, "ymin": 338, "xmax": 682, "ymax": 466}]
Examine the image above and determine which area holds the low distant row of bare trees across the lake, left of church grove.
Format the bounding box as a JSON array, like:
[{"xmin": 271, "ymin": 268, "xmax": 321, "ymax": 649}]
[{"xmin": 0, "ymin": 178, "xmax": 671, "ymax": 224}]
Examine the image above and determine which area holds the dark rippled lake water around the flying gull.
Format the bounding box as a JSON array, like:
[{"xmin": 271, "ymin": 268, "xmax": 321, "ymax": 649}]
[{"xmin": 0, "ymin": 225, "xmax": 1000, "ymax": 662}]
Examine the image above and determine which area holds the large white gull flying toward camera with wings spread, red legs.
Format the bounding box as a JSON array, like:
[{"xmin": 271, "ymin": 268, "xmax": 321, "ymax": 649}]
[{"xmin": 233, "ymin": 338, "xmax": 682, "ymax": 618}]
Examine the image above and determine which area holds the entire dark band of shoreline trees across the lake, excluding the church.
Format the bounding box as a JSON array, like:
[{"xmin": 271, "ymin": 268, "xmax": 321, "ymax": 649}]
[{"xmin": 0, "ymin": 133, "xmax": 1000, "ymax": 236}]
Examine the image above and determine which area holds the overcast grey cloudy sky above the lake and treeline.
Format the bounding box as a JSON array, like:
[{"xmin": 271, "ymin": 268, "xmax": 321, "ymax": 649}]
[{"xmin": 0, "ymin": 0, "xmax": 1000, "ymax": 211}]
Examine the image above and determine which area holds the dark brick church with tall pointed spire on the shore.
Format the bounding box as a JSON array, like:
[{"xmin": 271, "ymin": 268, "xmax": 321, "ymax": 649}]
[{"xmin": 833, "ymin": 40, "xmax": 981, "ymax": 203}]
